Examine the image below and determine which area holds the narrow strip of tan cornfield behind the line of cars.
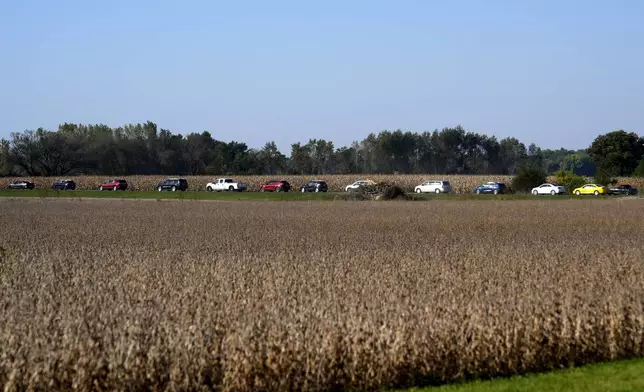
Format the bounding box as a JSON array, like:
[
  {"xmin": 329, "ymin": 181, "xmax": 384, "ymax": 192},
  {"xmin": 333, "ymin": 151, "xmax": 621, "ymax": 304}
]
[{"xmin": 0, "ymin": 174, "xmax": 644, "ymax": 193}]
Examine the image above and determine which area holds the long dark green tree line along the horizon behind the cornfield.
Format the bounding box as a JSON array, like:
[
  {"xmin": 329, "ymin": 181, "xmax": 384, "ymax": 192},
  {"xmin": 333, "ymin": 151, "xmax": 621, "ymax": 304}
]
[{"xmin": 0, "ymin": 121, "xmax": 644, "ymax": 176}]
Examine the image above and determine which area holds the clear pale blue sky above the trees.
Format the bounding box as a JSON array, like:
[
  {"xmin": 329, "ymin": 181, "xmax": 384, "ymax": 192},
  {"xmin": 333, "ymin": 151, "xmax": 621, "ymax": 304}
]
[{"xmin": 0, "ymin": 0, "xmax": 644, "ymax": 154}]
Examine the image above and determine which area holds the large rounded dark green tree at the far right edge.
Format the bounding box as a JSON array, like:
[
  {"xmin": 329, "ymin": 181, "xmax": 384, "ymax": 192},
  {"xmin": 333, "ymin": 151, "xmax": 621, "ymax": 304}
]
[{"xmin": 588, "ymin": 130, "xmax": 644, "ymax": 176}]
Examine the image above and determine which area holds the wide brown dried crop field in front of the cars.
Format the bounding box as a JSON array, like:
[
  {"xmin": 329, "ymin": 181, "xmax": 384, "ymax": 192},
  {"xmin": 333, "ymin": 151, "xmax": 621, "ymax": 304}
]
[{"xmin": 0, "ymin": 199, "xmax": 644, "ymax": 391}]
